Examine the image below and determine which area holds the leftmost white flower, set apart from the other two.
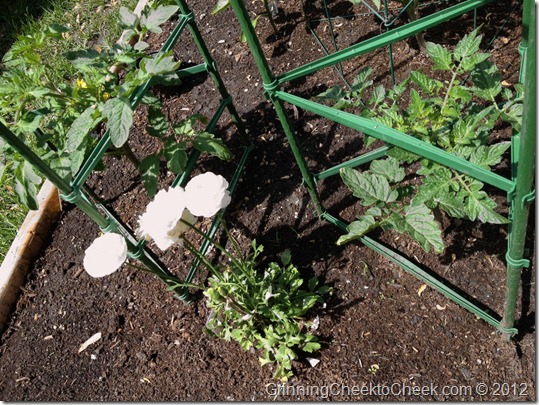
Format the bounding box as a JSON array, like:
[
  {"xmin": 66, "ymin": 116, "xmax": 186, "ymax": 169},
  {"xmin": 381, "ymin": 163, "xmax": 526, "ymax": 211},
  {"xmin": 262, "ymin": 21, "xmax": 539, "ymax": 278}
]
[{"xmin": 84, "ymin": 233, "xmax": 127, "ymax": 277}]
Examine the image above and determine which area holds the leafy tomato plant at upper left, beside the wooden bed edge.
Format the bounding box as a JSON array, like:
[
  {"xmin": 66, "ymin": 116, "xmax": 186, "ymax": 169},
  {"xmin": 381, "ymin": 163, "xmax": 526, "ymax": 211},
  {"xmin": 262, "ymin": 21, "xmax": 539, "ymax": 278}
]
[{"xmin": 0, "ymin": 1, "xmax": 231, "ymax": 209}]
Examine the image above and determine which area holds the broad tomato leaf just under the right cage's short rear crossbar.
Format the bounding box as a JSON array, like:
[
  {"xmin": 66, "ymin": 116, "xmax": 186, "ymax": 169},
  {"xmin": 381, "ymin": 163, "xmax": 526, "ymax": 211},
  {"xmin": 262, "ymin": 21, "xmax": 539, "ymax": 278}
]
[{"xmin": 340, "ymin": 167, "xmax": 398, "ymax": 205}]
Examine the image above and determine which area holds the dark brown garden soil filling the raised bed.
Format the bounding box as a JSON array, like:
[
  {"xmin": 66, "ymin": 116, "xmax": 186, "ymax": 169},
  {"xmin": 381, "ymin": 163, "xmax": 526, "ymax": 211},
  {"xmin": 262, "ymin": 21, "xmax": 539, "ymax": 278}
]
[{"xmin": 0, "ymin": 0, "xmax": 536, "ymax": 401}]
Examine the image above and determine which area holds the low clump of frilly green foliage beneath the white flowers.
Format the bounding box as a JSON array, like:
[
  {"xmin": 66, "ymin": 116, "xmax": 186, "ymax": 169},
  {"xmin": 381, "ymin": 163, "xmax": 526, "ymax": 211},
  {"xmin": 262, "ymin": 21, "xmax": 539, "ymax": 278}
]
[{"xmin": 204, "ymin": 241, "xmax": 331, "ymax": 381}]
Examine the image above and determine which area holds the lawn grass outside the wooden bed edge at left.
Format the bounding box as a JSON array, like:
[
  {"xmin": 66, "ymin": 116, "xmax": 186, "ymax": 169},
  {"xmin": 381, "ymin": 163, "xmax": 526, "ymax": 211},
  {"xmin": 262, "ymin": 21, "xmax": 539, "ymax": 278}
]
[{"xmin": 0, "ymin": 0, "xmax": 137, "ymax": 263}]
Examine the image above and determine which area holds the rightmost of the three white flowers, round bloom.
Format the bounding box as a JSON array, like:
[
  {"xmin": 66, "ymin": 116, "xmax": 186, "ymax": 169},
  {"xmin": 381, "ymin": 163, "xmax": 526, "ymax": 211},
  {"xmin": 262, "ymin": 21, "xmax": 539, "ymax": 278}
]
[{"xmin": 185, "ymin": 172, "xmax": 231, "ymax": 218}]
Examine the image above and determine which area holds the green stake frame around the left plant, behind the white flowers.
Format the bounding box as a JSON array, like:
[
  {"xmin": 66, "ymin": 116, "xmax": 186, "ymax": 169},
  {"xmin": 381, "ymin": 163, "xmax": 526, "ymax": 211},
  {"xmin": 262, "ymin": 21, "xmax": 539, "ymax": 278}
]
[{"xmin": 0, "ymin": 0, "xmax": 253, "ymax": 300}]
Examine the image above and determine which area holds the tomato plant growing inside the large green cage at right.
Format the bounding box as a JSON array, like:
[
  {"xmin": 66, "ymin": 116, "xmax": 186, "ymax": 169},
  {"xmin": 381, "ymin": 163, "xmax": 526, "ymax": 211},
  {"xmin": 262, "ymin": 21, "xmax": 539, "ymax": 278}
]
[{"xmin": 318, "ymin": 29, "xmax": 523, "ymax": 253}]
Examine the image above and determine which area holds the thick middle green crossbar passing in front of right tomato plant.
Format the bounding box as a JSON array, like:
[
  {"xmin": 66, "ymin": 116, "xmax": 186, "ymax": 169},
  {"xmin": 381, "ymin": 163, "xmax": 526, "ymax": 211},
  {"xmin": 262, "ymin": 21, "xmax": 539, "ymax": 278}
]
[{"xmin": 273, "ymin": 91, "xmax": 515, "ymax": 192}]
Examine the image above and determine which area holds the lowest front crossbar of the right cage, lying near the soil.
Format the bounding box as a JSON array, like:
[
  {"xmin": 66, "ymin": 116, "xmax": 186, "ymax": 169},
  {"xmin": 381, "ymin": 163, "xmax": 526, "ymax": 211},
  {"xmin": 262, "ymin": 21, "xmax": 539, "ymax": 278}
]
[{"xmin": 322, "ymin": 212, "xmax": 518, "ymax": 334}]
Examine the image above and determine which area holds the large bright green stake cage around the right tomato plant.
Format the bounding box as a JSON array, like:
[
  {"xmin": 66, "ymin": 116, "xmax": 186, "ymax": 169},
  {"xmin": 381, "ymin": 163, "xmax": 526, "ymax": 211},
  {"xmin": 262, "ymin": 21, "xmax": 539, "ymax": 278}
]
[{"xmin": 230, "ymin": 0, "xmax": 535, "ymax": 338}]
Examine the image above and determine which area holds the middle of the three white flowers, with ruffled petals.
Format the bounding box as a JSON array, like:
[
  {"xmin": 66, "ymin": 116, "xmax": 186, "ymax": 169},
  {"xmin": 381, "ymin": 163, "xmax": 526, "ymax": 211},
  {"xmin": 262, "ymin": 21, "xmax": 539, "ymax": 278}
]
[{"xmin": 137, "ymin": 187, "xmax": 196, "ymax": 250}]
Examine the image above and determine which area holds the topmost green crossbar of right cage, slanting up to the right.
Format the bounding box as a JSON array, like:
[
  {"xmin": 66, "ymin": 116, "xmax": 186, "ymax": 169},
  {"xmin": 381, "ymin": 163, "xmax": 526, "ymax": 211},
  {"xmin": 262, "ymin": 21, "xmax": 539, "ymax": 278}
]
[{"xmin": 276, "ymin": 0, "xmax": 492, "ymax": 84}]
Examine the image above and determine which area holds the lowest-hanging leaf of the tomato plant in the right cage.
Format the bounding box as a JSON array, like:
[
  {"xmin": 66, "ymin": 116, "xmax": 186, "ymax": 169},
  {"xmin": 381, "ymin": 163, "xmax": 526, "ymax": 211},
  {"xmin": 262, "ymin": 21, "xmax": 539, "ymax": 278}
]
[{"xmin": 404, "ymin": 204, "xmax": 445, "ymax": 253}]
